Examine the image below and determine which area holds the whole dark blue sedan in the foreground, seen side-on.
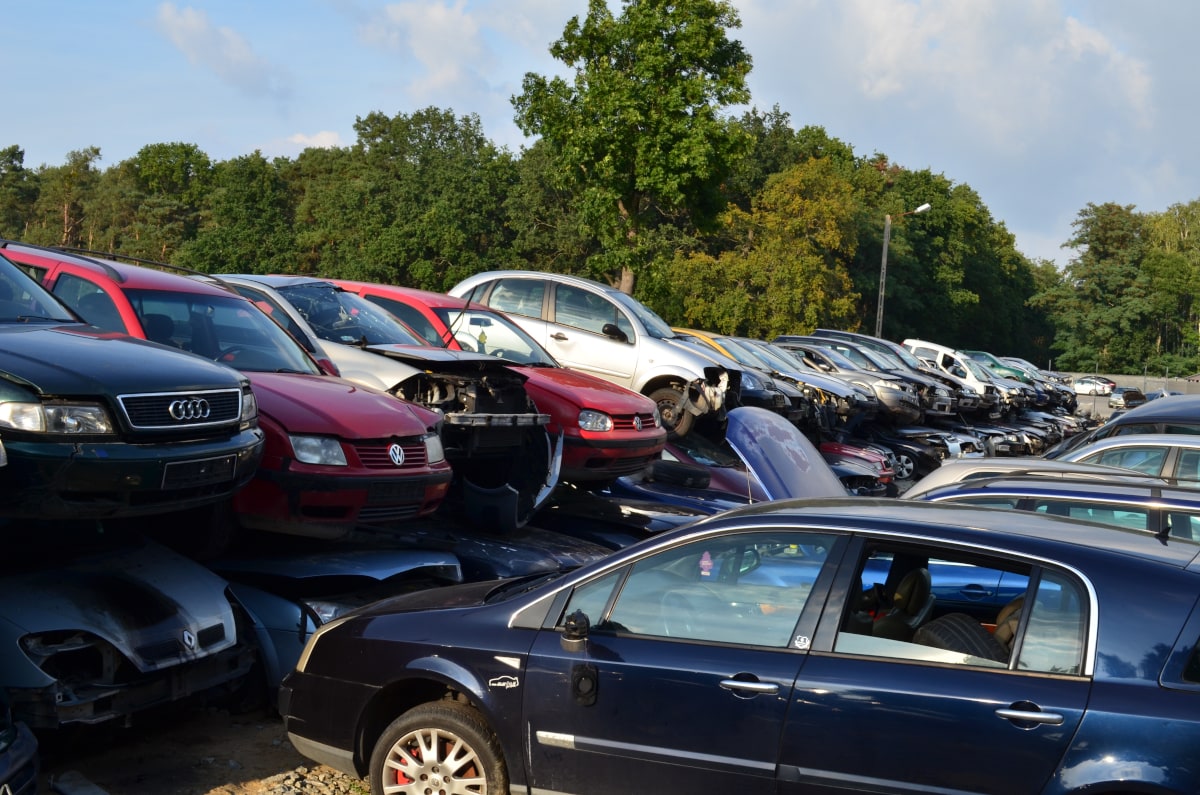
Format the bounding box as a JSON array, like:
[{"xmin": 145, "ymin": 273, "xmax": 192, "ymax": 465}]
[{"xmin": 280, "ymin": 497, "xmax": 1200, "ymax": 795}]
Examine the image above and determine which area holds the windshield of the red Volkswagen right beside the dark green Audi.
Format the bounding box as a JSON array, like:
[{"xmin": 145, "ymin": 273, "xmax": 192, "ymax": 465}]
[{"xmin": 125, "ymin": 289, "xmax": 320, "ymax": 373}]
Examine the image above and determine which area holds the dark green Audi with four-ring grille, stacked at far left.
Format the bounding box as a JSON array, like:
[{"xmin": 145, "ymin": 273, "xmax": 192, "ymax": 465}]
[{"xmin": 0, "ymin": 256, "xmax": 263, "ymax": 519}]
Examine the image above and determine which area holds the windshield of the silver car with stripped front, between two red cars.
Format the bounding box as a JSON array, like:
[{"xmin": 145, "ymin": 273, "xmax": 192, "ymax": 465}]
[{"xmin": 277, "ymin": 287, "xmax": 430, "ymax": 347}]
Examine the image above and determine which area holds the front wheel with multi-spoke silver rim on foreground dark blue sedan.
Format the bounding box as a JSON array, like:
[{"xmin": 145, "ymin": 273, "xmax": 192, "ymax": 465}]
[{"xmin": 370, "ymin": 701, "xmax": 509, "ymax": 793}]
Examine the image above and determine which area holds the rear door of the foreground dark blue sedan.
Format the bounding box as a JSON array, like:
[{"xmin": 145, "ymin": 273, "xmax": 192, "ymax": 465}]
[{"xmin": 780, "ymin": 543, "xmax": 1094, "ymax": 795}]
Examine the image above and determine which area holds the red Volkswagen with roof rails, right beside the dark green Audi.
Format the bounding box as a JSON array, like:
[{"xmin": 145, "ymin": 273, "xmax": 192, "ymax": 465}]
[{"xmin": 5, "ymin": 244, "xmax": 452, "ymax": 554}]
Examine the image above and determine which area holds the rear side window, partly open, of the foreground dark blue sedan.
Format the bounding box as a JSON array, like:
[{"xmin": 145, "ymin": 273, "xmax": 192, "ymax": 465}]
[{"xmin": 834, "ymin": 546, "xmax": 1088, "ymax": 674}]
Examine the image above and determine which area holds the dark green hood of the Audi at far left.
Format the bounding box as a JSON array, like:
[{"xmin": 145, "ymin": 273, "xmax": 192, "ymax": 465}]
[{"xmin": 0, "ymin": 325, "xmax": 245, "ymax": 396}]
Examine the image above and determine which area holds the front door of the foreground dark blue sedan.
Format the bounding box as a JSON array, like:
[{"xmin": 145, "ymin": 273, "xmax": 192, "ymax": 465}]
[{"xmin": 524, "ymin": 531, "xmax": 841, "ymax": 795}]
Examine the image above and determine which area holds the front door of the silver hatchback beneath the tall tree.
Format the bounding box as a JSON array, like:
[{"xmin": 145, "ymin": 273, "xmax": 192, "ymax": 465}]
[{"xmin": 539, "ymin": 285, "xmax": 638, "ymax": 389}]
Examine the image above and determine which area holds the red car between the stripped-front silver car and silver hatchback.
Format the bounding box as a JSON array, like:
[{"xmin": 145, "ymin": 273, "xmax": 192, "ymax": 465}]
[{"xmin": 329, "ymin": 279, "xmax": 667, "ymax": 484}]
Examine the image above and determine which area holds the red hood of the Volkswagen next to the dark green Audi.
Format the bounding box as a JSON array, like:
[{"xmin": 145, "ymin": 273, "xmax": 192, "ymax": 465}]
[{"xmin": 246, "ymin": 372, "xmax": 438, "ymax": 440}]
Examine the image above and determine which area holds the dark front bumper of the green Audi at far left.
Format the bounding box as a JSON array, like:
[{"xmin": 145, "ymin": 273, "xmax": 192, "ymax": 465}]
[{"xmin": 0, "ymin": 429, "xmax": 263, "ymax": 519}]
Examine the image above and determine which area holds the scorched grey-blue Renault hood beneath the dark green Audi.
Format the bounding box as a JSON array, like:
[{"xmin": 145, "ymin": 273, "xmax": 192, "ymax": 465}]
[{"xmin": 0, "ymin": 540, "xmax": 238, "ymax": 687}]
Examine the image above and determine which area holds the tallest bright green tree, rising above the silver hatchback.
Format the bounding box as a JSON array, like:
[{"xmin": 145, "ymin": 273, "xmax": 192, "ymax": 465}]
[{"xmin": 514, "ymin": 0, "xmax": 751, "ymax": 293}]
